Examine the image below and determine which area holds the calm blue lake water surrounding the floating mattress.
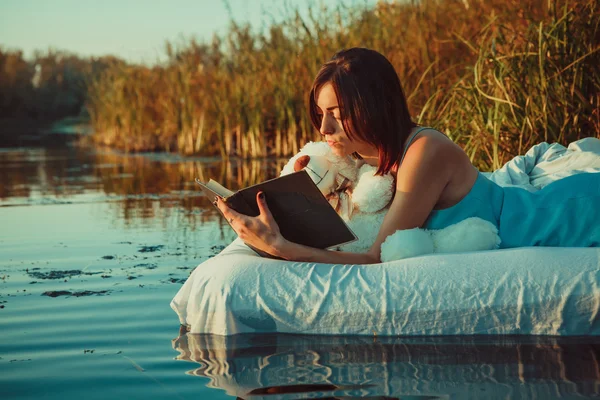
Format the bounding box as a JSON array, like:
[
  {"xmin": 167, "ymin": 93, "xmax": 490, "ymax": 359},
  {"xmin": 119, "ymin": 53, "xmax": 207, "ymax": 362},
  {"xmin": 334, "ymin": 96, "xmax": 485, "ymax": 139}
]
[{"xmin": 0, "ymin": 140, "xmax": 600, "ymax": 399}]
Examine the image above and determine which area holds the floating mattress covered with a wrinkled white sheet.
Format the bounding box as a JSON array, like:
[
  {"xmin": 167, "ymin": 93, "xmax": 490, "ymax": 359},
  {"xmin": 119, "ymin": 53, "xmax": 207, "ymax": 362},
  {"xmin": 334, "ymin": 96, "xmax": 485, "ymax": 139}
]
[{"xmin": 171, "ymin": 239, "xmax": 600, "ymax": 336}]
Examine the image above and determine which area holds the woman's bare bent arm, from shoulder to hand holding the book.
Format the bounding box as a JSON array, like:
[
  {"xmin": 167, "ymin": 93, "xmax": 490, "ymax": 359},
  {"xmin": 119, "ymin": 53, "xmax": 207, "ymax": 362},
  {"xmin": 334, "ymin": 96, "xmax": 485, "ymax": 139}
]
[{"xmin": 216, "ymin": 135, "xmax": 453, "ymax": 264}]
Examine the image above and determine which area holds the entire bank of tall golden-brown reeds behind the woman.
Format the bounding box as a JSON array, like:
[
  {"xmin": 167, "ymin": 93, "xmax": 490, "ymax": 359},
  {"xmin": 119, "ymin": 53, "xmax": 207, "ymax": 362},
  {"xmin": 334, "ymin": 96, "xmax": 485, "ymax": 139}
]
[{"xmin": 88, "ymin": 0, "xmax": 600, "ymax": 169}]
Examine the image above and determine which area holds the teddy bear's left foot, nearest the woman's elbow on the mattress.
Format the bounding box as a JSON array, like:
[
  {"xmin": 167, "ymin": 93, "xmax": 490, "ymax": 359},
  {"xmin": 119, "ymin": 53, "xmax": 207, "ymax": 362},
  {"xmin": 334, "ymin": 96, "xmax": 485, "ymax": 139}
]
[{"xmin": 381, "ymin": 228, "xmax": 434, "ymax": 262}]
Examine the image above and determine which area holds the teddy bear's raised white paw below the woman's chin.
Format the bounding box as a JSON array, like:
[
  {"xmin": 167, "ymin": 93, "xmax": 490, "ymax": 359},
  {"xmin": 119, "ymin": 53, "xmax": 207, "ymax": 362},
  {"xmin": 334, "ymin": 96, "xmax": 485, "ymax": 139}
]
[{"xmin": 352, "ymin": 164, "xmax": 394, "ymax": 213}]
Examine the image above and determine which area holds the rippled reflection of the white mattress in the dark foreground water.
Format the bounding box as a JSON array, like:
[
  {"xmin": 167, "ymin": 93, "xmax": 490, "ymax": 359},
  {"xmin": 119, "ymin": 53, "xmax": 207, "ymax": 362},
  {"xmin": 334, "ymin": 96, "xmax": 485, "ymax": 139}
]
[{"xmin": 173, "ymin": 332, "xmax": 600, "ymax": 399}]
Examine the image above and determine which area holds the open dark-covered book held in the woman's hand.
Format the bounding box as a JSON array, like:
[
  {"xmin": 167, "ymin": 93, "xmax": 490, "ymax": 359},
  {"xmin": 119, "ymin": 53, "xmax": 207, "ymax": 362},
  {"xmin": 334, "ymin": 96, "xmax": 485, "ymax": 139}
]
[{"xmin": 196, "ymin": 170, "xmax": 357, "ymax": 258}]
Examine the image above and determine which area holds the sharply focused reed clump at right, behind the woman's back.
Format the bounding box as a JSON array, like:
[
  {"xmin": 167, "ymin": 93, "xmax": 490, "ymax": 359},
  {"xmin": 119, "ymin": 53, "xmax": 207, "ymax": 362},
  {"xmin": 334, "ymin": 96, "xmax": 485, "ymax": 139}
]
[{"xmin": 419, "ymin": 1, "xmax": 600, "ymax": 170}]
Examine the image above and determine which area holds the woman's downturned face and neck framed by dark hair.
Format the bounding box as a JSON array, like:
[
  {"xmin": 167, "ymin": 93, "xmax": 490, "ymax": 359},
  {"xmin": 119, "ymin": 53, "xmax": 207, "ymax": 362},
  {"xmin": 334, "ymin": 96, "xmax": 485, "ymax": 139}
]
[{"xmin": 316, "ymin": 83, "xmax": 377, "ymax": 158}]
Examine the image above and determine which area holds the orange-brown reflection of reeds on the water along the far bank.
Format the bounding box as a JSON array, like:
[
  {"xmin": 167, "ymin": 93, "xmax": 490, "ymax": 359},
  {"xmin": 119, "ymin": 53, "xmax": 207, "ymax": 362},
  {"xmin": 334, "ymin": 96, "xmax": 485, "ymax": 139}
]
[{"xmin": 0, "ymin": 146, "xmax": 286, "ymax": 220}]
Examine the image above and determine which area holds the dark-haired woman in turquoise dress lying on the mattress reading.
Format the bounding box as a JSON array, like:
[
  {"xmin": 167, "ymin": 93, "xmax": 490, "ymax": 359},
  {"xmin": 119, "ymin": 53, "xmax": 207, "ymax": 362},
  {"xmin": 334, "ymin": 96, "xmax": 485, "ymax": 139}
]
[{"xmin": 215, "ymin": 48, "xmax": 600, "ymax": 264}]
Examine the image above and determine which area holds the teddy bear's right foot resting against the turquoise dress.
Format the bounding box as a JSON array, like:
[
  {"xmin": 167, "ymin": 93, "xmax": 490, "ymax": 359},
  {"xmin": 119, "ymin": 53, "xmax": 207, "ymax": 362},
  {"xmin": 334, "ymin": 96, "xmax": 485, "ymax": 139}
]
[{"xmin": 431, "ymin": 217, "xmax": 500, "ymax": 253}]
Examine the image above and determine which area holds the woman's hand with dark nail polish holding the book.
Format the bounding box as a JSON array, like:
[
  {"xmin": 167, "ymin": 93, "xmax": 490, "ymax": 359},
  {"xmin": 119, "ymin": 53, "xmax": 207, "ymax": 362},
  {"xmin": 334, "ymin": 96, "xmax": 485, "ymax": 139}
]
[{"xmin": 214, "ymin": 192, "xmax": 285, "ymax": 256}]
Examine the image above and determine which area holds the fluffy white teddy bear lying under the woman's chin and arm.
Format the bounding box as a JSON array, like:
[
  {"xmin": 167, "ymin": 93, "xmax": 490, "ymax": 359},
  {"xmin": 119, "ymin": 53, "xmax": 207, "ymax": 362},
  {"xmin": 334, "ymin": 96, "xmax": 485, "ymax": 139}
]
[{"xmin": 281, "ymin": 142, "xmax": 500, "ymax": 262}]
